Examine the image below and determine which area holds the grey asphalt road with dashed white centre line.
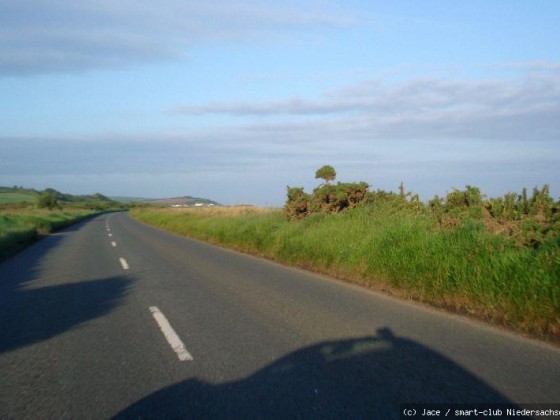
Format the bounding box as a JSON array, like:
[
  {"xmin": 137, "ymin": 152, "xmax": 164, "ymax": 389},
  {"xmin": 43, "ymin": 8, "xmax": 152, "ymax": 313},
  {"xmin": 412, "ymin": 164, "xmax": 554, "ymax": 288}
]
[{"xmin": 0, "ymin": 213, "xmax": 560, "ymax": 419}]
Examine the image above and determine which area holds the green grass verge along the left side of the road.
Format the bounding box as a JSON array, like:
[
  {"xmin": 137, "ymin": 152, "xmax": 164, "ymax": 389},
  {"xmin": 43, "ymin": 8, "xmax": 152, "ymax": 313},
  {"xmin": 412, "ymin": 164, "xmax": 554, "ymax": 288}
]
[{"xmin": 0, "ymin": 208, "xmax": 98, "ymax": 260}]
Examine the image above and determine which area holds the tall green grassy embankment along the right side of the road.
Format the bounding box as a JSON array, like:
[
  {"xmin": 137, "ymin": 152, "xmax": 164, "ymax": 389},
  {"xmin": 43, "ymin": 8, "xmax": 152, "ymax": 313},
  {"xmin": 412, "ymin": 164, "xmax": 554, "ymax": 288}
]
[{"xmin": 131, "ymin": 201, "xmax": 560, "ymax": 340}]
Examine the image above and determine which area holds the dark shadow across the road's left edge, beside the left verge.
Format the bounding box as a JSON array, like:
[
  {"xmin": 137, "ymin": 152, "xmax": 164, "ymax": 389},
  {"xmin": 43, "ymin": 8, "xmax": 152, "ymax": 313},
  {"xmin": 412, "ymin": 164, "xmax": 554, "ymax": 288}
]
[{"xmin": 0, "ymin": 224, "xmax": 131, "ymax": 353}]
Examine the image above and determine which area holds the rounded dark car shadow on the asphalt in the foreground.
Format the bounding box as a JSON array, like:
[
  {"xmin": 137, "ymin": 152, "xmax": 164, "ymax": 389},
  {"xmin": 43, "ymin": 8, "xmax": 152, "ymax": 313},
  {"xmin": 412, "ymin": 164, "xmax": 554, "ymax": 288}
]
[{"xmin": 115, "ymin": 328, "xmax": 510, "ymax": 419}]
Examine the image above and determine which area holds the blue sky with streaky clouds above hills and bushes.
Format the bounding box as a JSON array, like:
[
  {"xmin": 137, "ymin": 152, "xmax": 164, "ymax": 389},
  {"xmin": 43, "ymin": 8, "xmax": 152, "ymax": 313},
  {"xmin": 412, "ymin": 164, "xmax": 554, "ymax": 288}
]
[{"xmin": 0, "ymin": 0, "xmax": 560, "ymax": 206}]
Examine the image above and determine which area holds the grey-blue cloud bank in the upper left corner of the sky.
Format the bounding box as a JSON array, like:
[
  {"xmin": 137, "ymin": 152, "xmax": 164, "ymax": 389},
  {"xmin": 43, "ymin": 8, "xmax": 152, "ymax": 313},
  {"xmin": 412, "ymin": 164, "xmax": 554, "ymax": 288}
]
[{"xmin": 0, "ymin": 0, "xmax": 351, "ymax": 76}]
